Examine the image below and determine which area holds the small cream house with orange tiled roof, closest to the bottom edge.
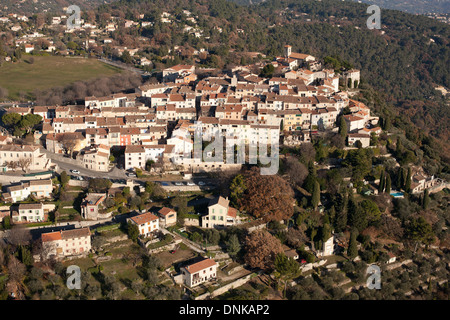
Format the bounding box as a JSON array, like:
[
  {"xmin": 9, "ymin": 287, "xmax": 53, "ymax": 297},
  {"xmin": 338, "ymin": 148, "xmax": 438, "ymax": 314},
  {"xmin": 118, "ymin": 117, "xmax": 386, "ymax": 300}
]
[{"xmin": 180, "ymin": 258, "xmax": 217, "ymax": 288}]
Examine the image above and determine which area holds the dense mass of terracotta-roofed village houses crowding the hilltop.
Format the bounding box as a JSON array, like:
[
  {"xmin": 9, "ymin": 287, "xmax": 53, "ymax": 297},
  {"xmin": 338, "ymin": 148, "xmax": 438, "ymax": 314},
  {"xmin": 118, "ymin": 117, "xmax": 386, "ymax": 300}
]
[{"xmin": 0, "ymin": 46, "xmax": 381, "ymax": 173}]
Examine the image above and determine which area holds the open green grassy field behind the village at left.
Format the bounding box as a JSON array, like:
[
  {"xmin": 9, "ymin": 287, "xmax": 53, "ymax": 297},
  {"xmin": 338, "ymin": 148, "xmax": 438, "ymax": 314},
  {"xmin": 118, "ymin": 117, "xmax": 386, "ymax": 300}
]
[{"xmin": 0, "ymin": 55, "xmax": 121, "ymax": 100}]
